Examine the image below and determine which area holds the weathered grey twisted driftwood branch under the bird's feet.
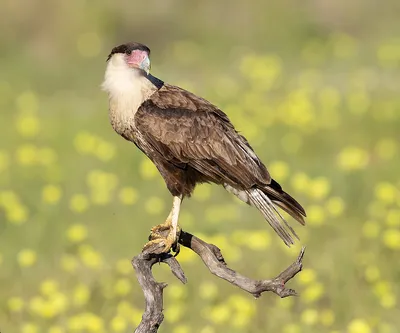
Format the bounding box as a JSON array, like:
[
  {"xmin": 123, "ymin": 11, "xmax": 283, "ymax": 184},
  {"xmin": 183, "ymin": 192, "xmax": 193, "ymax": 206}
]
[{"xmin": 132, "ymin": 231, "xmax": 305, "ymax": 333}]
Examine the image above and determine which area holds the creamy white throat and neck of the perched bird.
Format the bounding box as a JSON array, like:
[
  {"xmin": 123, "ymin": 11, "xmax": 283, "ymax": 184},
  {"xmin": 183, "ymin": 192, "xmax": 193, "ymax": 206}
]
[{"xmin": 102, "ymin": 54, "xmax": 157, "ymax": 134}]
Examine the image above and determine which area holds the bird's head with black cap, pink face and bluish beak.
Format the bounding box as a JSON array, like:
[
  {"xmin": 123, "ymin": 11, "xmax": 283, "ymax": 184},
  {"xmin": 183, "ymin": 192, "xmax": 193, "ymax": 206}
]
[{"xmin": 107, "ymin": 42, "xmax": 150, "ymax": 74}]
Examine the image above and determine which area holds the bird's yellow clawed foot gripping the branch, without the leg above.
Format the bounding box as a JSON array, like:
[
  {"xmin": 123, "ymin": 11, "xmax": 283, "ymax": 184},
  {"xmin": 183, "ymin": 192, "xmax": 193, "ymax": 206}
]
[{"xmin": 142, "ymin": 223, "xmax": 181, "ymax": 256}]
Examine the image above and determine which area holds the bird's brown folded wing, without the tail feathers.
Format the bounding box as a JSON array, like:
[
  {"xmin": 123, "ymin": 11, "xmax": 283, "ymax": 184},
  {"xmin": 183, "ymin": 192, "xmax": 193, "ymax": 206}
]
[{"xmin": 135, "ymin": 85, "xmax": 271, "ymax": 189}]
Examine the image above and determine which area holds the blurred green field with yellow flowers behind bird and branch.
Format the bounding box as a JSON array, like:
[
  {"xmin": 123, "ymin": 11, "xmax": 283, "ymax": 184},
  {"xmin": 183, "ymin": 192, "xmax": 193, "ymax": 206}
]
[{"xmin": 0, "ymin": 0, "xmax": 400, "ymax": 333}]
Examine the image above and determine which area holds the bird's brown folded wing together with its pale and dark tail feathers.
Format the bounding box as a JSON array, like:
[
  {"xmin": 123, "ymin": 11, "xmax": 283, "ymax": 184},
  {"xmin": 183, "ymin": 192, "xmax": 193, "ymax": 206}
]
[{"xmin": 135, "ymin": 85, "xmax": 305, "ymax": 246}]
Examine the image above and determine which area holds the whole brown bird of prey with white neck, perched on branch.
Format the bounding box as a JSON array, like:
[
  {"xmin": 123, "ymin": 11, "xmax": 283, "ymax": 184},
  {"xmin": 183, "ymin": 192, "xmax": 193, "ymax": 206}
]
[{"xmin": 102, "ymin": 42, "xmax": 306, "ymax": 253}]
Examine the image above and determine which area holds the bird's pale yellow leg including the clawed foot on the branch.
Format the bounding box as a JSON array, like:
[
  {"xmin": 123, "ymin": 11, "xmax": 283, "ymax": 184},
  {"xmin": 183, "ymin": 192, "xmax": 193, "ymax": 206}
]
[{"xmin": 143, "ymin": 196, "xmax": 182, "ymax": 253}]
